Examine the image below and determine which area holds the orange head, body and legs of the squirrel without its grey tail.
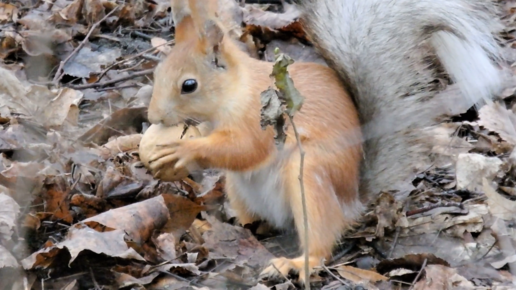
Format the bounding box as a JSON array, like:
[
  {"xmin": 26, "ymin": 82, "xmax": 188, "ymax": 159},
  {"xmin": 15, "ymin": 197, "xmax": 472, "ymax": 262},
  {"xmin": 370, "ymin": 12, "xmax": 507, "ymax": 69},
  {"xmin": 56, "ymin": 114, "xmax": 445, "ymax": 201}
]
[{"xmin": 149, "ymin": 0, "xmax": 364, "ymax": 277}]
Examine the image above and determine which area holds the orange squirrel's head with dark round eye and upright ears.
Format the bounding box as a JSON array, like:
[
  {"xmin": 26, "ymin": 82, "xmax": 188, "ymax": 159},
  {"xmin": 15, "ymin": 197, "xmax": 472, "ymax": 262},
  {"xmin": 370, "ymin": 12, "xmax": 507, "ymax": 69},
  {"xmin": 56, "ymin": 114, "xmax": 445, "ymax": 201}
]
[{"xmin": 149, "ymin": 0, "xmax": 238, "ymax": 126}]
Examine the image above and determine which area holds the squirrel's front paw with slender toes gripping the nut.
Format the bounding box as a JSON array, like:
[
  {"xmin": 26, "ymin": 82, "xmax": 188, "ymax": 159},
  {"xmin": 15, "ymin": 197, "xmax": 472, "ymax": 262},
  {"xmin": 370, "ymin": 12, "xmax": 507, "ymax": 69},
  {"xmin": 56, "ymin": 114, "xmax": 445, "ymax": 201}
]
[{"xmin": 149, "ymin": 140, "xmax": 196, "ymax": 177}]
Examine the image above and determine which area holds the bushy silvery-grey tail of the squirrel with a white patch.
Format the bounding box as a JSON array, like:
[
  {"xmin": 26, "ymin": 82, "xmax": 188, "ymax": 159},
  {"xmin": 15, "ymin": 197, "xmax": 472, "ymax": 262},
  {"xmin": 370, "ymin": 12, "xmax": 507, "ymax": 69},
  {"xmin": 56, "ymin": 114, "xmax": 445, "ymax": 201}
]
[{"xmin": 297, "ymin": 0, "xmax": 502, "ymax": 197}]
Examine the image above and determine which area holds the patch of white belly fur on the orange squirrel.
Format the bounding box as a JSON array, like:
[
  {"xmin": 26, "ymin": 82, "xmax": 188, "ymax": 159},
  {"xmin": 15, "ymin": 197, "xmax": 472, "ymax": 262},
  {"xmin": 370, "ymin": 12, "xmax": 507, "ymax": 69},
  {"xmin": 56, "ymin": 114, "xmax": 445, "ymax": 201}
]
[{"xmin": 227, "ymin": 162, "xmax": 293, "ymax": 229}]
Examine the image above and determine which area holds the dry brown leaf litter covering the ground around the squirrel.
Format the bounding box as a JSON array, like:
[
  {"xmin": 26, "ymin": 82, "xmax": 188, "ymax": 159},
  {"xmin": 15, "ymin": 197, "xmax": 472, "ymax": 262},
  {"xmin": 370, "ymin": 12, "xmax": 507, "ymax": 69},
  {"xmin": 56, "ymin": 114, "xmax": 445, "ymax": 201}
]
[{"xmin": 0, "ymin": 0, "xmax": 516, "ymax": 289}]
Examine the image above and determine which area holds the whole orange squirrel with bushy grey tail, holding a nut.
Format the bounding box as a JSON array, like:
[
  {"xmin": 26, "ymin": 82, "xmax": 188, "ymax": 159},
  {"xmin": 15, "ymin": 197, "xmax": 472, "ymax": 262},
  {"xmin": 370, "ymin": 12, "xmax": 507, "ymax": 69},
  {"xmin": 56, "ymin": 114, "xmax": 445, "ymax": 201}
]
[{"xmin": 148, "ymin": 0, "xmax": 503, "ymax": 279}]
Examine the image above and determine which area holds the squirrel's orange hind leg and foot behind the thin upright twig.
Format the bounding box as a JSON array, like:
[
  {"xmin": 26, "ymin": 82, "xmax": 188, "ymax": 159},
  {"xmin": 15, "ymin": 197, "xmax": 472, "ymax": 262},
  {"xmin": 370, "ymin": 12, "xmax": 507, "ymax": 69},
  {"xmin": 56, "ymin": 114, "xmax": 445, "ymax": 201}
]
[{"xmin": 261, "ymin": 152, "xmax": 353, "ymax": 281}]
